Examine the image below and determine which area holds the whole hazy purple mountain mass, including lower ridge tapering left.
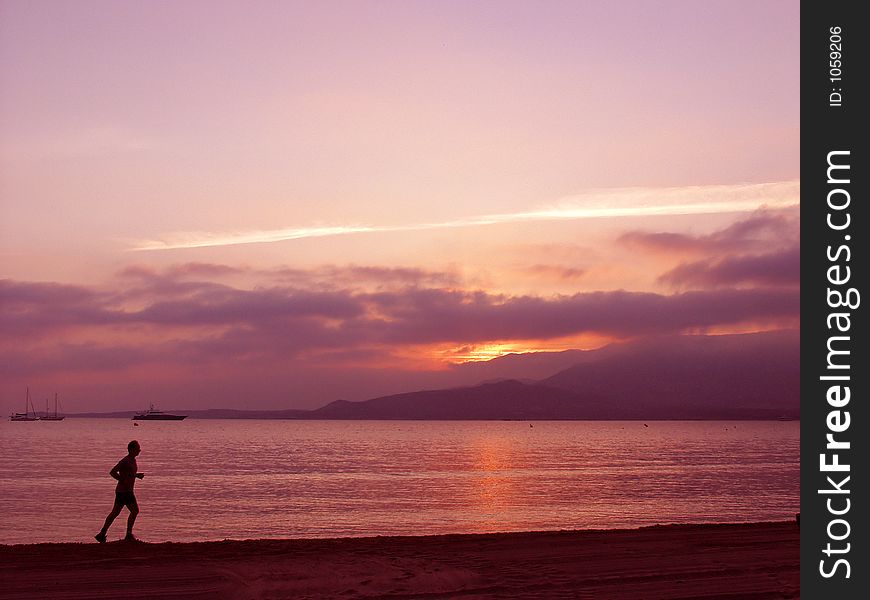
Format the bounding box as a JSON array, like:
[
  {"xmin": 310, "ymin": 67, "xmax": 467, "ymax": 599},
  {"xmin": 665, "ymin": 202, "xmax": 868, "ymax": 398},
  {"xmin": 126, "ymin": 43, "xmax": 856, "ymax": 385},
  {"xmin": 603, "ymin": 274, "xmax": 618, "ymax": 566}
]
[{"xmin": 307, "ymin": 331, "xmax": 800, "ymax": 419}]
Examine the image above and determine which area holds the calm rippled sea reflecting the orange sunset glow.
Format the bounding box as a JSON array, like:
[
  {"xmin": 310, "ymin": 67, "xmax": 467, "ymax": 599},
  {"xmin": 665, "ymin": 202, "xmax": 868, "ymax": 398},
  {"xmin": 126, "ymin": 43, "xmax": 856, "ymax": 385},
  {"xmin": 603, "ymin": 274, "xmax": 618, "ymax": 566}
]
[{"xmin": 0, "ymin": 419, "xmax": 800, "ymax": 544}]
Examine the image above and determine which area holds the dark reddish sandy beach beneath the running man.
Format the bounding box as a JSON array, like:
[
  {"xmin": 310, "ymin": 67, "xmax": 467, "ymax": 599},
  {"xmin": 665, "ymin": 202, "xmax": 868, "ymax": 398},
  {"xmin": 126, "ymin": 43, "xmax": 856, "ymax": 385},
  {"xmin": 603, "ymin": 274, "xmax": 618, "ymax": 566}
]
[{"xmin": 0, "ymin": 522, "xmax": 799, "ymax": 600}]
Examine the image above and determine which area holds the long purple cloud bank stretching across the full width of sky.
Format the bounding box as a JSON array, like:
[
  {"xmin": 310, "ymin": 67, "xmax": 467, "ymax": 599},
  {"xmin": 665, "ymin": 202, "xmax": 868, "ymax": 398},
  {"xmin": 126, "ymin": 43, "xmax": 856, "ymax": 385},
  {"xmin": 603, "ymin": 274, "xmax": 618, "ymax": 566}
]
[{"xmin": 0, "ymin": 264, "xmax": 800, "ymax": 374}]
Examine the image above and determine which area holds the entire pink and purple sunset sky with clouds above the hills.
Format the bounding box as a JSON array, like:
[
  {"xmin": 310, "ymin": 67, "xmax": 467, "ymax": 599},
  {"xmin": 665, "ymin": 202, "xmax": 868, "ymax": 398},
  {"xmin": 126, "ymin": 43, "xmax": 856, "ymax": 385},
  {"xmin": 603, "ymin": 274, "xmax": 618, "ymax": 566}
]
[{"xmin": 0, "ymin": 0, "xmax": 800, "ymax": 415}]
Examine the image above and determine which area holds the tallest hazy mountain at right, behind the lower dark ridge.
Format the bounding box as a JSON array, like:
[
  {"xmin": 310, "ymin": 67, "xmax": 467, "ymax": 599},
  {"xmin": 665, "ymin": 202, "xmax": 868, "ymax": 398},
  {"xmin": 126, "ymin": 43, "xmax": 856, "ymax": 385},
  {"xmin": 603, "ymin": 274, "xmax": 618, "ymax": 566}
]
[{"xmin": 542, "ymin": 331, "xmax": 800, "ymax": 416}]
